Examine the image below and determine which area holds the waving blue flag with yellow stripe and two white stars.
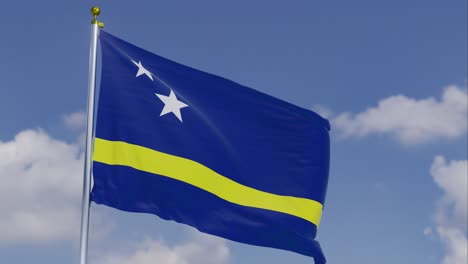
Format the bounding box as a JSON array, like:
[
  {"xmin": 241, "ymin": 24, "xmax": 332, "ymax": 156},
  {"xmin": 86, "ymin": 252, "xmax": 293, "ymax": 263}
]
[{"xmin": 91, "ymin": 31, "xmax": 330, "ymax": 264}]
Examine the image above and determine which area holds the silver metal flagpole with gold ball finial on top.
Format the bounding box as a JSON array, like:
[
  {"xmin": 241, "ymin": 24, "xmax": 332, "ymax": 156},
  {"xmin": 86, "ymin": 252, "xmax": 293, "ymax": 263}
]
[{"xmin": 80, "ymin": 6, "xmax": 104, "ymax": 264}]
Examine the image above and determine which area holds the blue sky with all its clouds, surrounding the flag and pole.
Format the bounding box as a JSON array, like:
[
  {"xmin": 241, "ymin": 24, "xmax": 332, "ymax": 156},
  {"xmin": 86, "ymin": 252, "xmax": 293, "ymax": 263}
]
[{"xmin": 0, "ymin": 0, "xmax": 468, "ymax": 264}]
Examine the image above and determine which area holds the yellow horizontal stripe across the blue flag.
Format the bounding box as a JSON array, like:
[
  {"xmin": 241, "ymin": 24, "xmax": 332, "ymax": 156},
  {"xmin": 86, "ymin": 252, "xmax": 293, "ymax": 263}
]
[{"xmin": 94, "ymin": 138, "xmax": 323, "ymax": 227}]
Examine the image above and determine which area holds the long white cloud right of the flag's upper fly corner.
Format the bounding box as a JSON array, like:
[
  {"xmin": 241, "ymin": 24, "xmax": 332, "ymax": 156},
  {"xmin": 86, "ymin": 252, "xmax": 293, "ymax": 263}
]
[{"xmin": 332, "ymin": 86, "xmax": 468, "ymax": 144}]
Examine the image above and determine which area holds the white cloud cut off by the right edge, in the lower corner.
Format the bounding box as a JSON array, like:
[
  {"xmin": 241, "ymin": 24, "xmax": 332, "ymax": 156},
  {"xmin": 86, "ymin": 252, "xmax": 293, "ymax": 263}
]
[{"xmin": 431, "ymin": 156, "xmax": 468, "ymax": 264}]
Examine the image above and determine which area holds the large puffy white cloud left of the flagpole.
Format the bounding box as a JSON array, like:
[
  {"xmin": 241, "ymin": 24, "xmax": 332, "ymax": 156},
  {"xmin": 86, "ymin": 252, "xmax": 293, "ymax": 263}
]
[{"xmin": 0, "ymin": 130, "xmax": 83, "ymax": 244}]
